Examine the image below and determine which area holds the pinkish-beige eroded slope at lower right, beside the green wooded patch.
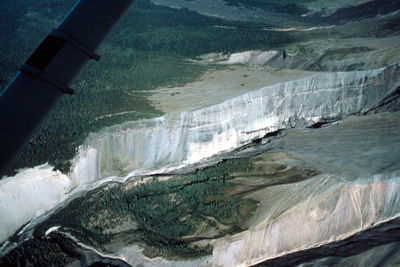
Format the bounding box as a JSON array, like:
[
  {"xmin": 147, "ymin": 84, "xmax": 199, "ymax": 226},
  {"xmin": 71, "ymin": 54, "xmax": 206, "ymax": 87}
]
[{"xmin": 213, "ymin": 172, "xmax": 400, "ymax": 266}]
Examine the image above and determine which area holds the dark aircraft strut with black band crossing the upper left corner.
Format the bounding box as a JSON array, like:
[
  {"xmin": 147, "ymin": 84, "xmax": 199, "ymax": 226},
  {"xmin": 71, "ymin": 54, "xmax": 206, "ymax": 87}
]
[{"xmin": 0, "ymin": 0, "xmax": 133, "ymax": 178}]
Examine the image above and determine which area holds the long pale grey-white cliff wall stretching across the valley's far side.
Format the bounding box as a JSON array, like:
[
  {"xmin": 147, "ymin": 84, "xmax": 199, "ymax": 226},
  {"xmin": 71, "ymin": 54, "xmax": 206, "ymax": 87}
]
[{"xmin": 0, "ymin": 65, "xmax": 400, "ymax": 245}]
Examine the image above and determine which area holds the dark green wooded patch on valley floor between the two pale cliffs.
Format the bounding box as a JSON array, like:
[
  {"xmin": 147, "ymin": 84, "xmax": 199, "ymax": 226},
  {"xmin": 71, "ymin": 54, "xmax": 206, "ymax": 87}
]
[{"xmin": 34, "ymin": 159, "xmax": 257, "ymax": 259}]
